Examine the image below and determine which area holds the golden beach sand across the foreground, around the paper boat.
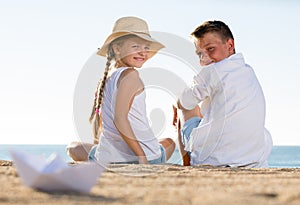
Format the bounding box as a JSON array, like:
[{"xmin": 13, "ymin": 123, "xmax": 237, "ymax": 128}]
[{"xmin": 0, "ymin": 160, "xmax": 300, "ymax": 205}]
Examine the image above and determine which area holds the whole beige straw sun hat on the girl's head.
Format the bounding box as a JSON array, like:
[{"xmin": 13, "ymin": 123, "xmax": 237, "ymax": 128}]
[{"xmin": 97, "ymin": 16, "xmax": 165, "ymax": 57}]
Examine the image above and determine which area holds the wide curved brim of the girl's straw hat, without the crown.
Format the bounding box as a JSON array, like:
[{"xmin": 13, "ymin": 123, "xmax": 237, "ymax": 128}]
[{"xmin": 97, "ymin": 31, "xmax": 165, "ymax": 58}]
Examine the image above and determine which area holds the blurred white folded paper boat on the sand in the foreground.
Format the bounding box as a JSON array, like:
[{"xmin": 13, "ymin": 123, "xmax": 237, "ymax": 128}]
[{"xmin": 10, "ymin": 150, "xmax": 105, "ymax": 193}]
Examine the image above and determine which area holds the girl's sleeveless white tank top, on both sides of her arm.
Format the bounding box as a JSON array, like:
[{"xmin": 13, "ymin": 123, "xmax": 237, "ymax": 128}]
[{"xmin": 95, "ymin": 67, "xmax": 161, "ymax": 162}]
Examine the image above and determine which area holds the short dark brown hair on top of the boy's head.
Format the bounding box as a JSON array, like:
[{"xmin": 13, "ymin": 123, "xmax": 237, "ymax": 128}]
[{"xmin": 191, "ymin": 21, "xmax": 234, "ymax": 41}]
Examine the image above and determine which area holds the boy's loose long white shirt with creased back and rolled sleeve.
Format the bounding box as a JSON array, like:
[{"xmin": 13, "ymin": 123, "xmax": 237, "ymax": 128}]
[{"xmin": 179, "ymin": 54, "xmax": 272, "ymax": 167}]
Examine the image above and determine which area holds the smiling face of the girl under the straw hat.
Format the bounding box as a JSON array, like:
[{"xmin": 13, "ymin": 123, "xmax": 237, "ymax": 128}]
[{"xmin": 113, "ymin": 37, "xmax": 150, "ymax": 68}]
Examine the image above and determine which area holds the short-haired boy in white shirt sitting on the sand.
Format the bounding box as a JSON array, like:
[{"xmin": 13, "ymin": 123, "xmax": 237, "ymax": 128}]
[{"xmin": 174, "ymin": 21, "xmax": 272, "ymax": 167}]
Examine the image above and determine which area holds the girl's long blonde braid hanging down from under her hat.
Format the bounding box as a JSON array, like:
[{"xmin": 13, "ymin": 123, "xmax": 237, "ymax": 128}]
[{"xmin": 89, "ymin": 46, "xmax": 114, "ymax": 143}]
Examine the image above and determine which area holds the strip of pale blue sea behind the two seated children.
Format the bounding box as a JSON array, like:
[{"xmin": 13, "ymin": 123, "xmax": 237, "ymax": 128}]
[{"xmin": 0, "ymin": 144, "xmax": 300, "ymax": 168}]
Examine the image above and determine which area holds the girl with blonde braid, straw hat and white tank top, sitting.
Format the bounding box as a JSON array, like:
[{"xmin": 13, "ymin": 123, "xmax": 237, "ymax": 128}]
[{"xmin": 69, "ymin": 17, "xmax": 175, "ymax": 164}]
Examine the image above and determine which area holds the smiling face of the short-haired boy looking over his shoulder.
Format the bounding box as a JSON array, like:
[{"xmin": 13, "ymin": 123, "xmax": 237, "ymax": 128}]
[{"xmin": 195, "ymin": 32, "xmax": 234, "ymax": 63}]
